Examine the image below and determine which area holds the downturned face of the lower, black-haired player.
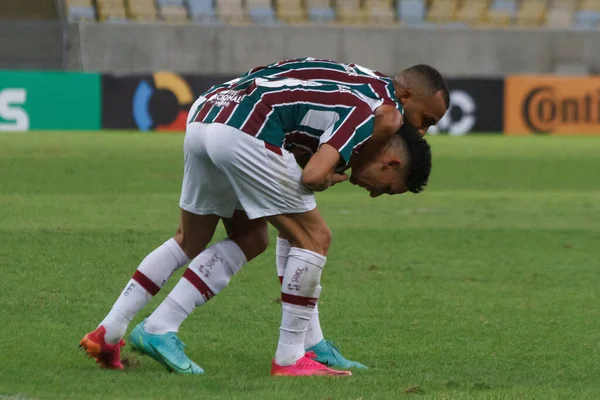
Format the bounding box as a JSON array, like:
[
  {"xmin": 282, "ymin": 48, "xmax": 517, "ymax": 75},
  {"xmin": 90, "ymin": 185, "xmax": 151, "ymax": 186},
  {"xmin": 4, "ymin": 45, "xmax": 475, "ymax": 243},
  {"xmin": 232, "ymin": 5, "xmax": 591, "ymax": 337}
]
[{"xmin": 350, "ymin": 152, "xmax": 408, "ymax": 197}]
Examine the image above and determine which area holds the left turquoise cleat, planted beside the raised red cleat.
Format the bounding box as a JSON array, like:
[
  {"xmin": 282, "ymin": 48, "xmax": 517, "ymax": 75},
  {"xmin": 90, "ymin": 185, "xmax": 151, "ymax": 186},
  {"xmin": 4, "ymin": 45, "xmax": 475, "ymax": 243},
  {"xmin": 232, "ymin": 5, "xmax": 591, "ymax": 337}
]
[{"xmin": 129, "ymin": 321, "xmax": 204, "ymax": 375}]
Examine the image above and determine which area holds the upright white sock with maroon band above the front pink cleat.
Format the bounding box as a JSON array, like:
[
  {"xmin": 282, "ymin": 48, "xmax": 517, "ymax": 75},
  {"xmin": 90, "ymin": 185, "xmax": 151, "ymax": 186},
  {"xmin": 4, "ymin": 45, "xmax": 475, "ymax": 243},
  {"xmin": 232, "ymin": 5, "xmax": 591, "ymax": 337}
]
[{"xmin": 275, "ymin": 247, "xmax": 327, "ymax": 366}]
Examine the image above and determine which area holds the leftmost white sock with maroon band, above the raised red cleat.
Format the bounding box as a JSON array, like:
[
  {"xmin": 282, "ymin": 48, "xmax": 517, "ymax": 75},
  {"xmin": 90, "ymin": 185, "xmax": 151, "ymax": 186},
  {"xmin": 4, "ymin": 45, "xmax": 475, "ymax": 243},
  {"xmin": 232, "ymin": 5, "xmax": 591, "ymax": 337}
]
[{"xmin": 100, "ymin": 238, "xmax": 189, "ymax": 344}]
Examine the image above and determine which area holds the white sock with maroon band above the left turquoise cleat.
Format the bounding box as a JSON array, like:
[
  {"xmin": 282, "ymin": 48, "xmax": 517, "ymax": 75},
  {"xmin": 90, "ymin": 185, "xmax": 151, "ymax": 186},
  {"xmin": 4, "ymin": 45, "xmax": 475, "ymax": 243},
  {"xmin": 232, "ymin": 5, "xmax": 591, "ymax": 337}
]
[{"xmin": 144, "ymin": 239, "xmax": 246, "ymax": 335}]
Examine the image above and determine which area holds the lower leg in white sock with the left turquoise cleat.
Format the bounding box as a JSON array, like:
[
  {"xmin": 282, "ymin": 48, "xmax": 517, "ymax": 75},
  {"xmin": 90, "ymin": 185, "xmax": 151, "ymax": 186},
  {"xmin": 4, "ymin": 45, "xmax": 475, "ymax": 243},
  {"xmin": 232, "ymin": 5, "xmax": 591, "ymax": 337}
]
[{"xmin": 130, "ymin": 210, "xmax": 268, "ymax": 374}]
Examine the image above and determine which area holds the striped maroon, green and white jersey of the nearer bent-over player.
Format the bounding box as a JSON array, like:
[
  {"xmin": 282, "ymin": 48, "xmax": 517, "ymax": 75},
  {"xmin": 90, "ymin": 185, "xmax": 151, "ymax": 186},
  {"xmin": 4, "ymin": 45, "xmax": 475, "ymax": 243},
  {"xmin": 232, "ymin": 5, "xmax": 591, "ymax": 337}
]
[{"xmin": 190, "ymin": 74, "xmax": 383, "ymax": 163}]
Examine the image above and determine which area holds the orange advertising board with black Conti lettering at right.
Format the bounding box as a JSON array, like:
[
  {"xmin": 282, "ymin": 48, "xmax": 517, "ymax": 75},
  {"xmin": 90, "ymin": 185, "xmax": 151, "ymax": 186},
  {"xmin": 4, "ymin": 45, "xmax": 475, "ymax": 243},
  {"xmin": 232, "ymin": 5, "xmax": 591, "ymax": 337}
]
[{"xmin": 504, "ymin": 76, "xmax": 600, "ymax": 135}]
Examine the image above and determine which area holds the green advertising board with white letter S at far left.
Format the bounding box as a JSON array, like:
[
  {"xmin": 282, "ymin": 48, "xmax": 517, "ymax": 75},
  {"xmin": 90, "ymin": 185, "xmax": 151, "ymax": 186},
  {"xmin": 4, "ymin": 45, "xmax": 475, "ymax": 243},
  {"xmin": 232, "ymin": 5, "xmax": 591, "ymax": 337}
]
[{"xmin": 0, "ymin": 71, "xmax": 101, "ymax": 131}]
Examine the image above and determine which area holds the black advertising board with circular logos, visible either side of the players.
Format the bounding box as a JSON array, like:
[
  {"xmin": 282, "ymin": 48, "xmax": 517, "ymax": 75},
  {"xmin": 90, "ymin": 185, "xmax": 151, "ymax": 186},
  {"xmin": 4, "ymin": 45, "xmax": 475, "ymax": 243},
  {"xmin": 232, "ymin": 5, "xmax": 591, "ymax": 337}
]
[{"xmin": 102, "ymin": 72, "xmax": 504, "ymax": 135}]
